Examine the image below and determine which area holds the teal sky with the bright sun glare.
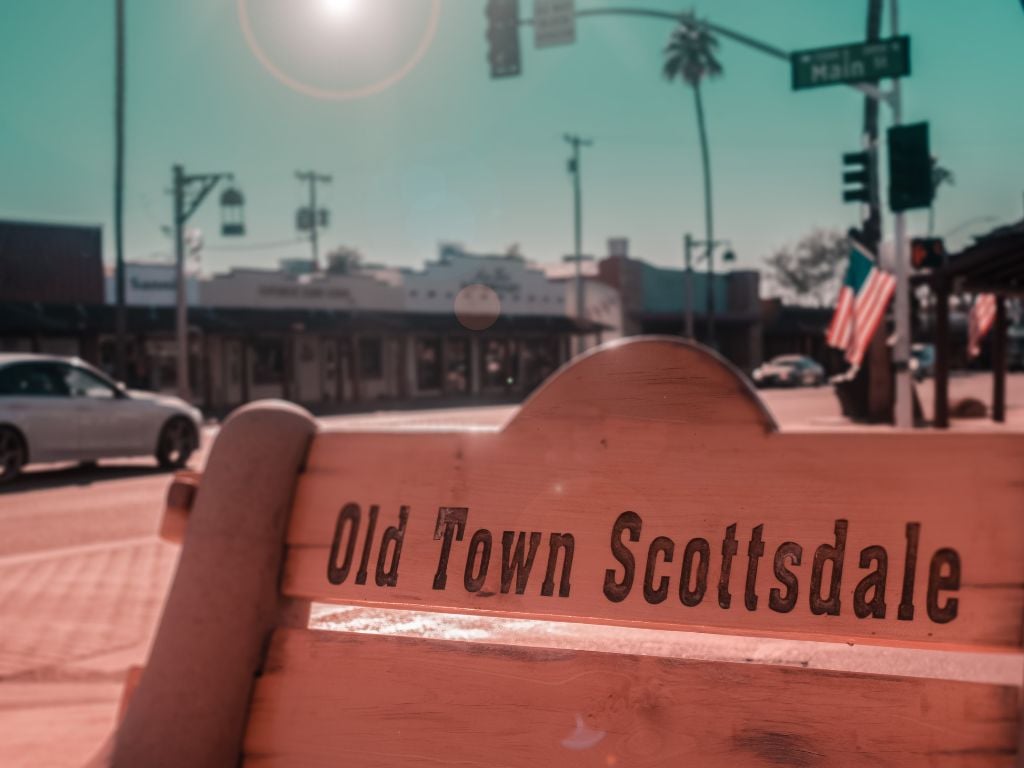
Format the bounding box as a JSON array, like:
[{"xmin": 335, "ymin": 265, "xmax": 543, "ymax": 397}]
[{"xmin": 0, "ymin": 0, "xmax": 1024, "ymax": 280}]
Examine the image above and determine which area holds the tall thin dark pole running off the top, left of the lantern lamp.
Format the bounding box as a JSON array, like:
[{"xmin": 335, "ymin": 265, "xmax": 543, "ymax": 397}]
[{"xmin": 114, "ymin": 0, "xmax": 127, "ymax": 381}]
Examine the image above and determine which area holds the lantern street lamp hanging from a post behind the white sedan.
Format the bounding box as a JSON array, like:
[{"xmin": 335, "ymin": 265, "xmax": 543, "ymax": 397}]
[{"xmin": 171, "ymin": 165, "xmax": 245, "ymax": 401}]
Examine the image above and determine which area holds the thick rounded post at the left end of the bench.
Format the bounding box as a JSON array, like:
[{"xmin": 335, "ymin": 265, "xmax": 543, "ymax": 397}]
[{"xmin": 111, "ymin": 402, "xmax": 316, "ymax": 768}]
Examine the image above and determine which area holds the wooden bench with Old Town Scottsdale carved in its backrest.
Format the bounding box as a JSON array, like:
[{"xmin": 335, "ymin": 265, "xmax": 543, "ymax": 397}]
[{"xmin": 101, "ymin": 338, "xmax": 1024, "ymax": 768}]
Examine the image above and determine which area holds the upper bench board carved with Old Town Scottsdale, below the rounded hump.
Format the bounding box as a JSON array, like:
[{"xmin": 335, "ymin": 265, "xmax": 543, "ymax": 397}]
[{"xmin": 283, "ymin": 428, "xmax": 1024, "ymax": 648}]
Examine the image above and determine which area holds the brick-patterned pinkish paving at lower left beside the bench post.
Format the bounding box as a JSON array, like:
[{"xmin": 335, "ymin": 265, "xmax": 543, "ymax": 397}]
[{"xmin": 0, "ymin": 538, "xmax": 178, "ymax": 768}]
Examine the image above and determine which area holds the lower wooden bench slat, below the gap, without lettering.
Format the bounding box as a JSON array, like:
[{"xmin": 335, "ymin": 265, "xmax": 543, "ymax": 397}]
[{"xmin": 245, "ymin": 630, "xmax": 1019, "ymax": 768}]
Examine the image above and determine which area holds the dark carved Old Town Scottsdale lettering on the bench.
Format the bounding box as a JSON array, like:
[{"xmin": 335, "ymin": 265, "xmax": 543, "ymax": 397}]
[{"xmin": 327, "ymin": 502, "xmax": 962, "ymax": 624}]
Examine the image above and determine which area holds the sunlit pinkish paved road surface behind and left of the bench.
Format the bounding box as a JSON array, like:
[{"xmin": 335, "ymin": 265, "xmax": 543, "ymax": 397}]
[{"xmin": 0, "ymin": 376, "xmax": 1024, "ymax": 768}]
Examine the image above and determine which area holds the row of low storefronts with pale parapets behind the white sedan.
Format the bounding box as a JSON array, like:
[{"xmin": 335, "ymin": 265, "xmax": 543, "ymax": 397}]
[{"xmin": 0, "ymin": 233, "xmax": 597, "ymax": 414}]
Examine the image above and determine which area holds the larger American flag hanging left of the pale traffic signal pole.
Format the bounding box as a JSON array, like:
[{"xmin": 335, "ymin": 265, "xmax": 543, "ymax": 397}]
[{"xmin": 825, "ymin": 241, "xmax": 896, "ymax": 368}]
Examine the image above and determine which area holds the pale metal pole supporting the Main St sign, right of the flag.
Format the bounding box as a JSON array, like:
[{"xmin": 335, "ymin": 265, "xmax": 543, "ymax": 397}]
[{"xmin": 889, "ymin": 0, "xmax": 913, "ymax": 429}]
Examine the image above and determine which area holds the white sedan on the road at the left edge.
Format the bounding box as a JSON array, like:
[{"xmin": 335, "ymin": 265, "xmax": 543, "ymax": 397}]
[{"xmin": 0, "ymin": 353, "xmax": 202, "ymax": 483}]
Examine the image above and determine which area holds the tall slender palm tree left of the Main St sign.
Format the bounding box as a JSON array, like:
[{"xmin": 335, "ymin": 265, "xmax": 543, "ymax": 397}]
[{"xmin": 662, "ymin": 11, "xmax": 722, "ymax": 347}]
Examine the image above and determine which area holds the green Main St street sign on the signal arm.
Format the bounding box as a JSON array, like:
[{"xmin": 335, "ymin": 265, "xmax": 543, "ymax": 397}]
[{"xmin": 790, "ymin": 35, "xmax": 910, "ymax": 91}]
